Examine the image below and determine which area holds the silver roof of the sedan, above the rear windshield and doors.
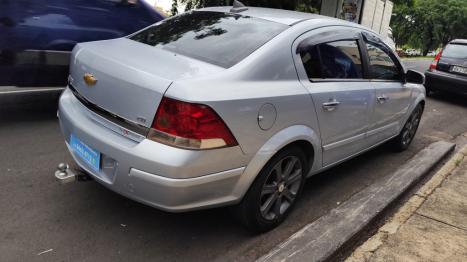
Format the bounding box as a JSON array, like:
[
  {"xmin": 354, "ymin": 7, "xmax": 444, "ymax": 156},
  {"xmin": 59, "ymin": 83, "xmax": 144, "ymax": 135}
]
[{"xmin": 196, "ymin": 6, "xmax": 333, "ymax": 26}]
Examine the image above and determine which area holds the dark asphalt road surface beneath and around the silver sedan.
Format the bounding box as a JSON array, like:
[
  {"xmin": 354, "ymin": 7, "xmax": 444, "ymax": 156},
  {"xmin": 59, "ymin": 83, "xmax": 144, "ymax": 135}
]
[{"xmin": 0, "ymin": 61, "xmax": 467, "ymax": 261}]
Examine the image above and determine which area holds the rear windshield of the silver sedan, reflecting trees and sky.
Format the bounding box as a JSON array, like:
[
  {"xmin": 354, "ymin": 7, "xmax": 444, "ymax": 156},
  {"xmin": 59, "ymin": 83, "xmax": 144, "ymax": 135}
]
[{"xmin": 130, "ymin": 11, "xmax": 288, "ymax": 68}]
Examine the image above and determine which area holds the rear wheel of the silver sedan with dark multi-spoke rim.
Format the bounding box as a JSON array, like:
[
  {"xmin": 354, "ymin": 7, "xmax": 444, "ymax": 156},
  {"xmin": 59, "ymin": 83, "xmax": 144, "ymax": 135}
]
[{"xmin": 237, "ymin": 146, "xmax": 308, "ymax": 232}]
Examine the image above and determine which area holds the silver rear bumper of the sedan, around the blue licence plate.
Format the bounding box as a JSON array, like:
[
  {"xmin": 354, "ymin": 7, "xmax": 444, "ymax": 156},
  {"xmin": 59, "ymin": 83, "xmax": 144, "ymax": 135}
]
[{"xmin": 59, "ymin": 89, "xmax": 249, "ymax": 212}]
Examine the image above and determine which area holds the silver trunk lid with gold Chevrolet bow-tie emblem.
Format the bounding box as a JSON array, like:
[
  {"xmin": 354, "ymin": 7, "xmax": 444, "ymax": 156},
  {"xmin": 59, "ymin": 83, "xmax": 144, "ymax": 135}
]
[{"xmin": 70, "ymin": 38, "xmax": 223, "ymax": 127}]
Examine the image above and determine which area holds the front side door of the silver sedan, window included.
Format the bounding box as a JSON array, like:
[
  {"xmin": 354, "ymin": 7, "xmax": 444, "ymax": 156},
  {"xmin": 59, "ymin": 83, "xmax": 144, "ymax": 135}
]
[{"xmin": 363, "ymin": 33, "xmax": 412, "ymax": 146}]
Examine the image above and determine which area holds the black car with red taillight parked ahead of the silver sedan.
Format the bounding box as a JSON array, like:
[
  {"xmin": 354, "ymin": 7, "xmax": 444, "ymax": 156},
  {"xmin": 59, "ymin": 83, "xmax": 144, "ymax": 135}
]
[{"xmin": 425, "ymin": 39, "xmax": 467, "ymax": 94}]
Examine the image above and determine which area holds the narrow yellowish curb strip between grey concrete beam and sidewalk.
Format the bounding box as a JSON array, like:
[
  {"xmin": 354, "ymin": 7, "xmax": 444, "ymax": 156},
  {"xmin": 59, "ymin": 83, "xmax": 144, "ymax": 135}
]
[{"xmin": 346, "ymin": 145, "xmax": 467, "ymax": 262}]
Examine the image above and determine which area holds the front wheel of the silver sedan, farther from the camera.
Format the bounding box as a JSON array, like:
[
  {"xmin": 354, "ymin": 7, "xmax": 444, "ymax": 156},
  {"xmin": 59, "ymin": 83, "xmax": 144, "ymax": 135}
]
[{"xmin": 392, "ymin": 104, "xmax": 423, "ymax": 152}]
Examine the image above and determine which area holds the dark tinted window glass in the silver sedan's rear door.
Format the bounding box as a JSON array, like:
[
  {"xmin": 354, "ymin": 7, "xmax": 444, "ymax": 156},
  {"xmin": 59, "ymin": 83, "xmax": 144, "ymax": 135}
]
[{"xmin": 300, "ymin": 40, "xmax": 363, "ymax": 79}]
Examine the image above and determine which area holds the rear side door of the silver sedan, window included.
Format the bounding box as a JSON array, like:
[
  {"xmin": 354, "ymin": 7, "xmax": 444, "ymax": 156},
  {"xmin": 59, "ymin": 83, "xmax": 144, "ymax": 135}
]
[{"xmin": 293, "ymin": 26, "xmax": 375, "ymax": 166}]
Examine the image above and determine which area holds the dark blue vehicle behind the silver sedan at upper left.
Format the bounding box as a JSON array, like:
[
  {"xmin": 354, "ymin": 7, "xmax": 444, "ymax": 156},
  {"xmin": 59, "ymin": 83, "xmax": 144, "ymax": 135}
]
[{"xmin": 0, "ymin": 0, "xmax": 164, "ymax": 87}]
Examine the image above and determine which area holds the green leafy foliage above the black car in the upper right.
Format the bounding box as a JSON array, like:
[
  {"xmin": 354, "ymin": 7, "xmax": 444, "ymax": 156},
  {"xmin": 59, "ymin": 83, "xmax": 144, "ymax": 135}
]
[{"xmin": 391, "ymin": 0, "xmax": 467, "ymax": 55}]
